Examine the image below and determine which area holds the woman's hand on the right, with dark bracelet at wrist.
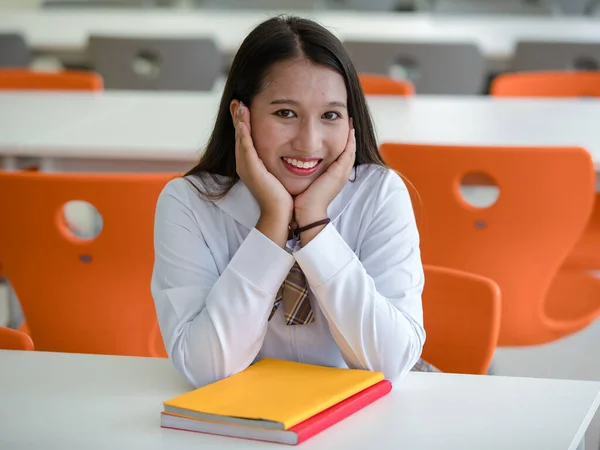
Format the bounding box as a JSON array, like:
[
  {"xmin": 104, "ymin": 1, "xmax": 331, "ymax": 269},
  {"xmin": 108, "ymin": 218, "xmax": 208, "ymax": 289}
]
[{"xmin": 294, "ymin": 126, "xmax": 356, "ymax": 245}]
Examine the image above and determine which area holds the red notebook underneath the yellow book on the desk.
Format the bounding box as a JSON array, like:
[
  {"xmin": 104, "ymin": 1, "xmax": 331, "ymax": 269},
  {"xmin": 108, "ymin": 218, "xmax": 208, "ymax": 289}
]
[{"xmin": 161, "ymin": 380, "xmax": 392, "ymax": 445}]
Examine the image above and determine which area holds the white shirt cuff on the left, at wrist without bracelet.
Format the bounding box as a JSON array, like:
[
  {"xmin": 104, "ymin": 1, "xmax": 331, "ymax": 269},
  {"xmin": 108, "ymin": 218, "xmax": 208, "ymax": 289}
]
[{"xmin": 229, "ymin": 228, "xmax": 294, "ymax": 294}]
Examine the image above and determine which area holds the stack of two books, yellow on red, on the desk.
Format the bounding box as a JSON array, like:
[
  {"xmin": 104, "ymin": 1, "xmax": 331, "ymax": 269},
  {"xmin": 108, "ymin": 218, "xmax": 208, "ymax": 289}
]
[{"xmin": 161, "ymin": 359, "xmax": 392, "ymax": 445}]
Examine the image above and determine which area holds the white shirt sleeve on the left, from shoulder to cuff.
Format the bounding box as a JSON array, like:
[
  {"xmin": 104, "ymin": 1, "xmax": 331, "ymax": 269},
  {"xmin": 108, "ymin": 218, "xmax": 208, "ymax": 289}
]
[{"xmin": 151, "ymin": 179, "xmax": 294, "ymax": 387}]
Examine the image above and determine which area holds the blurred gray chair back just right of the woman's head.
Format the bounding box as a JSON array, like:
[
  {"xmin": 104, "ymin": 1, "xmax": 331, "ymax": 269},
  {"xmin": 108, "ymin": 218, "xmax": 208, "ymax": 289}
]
[{"xmin": 344, "ymin": 41, "xmax": 485, "ymax": 95}]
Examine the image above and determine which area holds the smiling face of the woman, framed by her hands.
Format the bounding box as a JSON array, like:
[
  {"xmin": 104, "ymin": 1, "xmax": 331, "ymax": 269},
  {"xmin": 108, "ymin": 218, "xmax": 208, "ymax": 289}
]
[{"xmin": 244, "ymin": 58, "xmax": 350, "ymax": 195}]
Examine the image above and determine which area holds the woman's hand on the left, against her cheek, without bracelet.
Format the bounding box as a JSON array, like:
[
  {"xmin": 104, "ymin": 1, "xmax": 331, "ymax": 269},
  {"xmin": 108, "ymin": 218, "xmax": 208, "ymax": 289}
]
[{"xmin": 234, "ymin": 102, "xmax": 294, "ymax": 247}]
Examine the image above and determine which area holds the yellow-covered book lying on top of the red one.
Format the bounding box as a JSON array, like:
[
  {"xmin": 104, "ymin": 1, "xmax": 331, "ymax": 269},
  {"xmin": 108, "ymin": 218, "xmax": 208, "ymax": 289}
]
[{"xmin": 163, "ymin": 358, "xmax": 384, "ymax": 430}]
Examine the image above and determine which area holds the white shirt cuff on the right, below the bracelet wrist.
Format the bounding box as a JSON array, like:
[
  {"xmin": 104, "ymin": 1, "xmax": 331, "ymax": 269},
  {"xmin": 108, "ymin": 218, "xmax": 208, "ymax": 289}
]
[{"xmin": 294, "ymin": 223, "xmax": 356, "ymax": 289}]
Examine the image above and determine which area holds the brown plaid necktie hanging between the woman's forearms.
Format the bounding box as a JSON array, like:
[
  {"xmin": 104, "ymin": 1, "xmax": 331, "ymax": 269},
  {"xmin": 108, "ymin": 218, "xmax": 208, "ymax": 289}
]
[{"xmin": 269, "ymin": 263, "xmax": 315, "ymax": 325}]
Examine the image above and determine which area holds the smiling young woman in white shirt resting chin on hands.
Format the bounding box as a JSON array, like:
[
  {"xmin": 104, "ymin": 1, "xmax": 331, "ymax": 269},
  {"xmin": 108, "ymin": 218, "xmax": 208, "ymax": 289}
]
[{"xmin": 152, "ymin": 17, "xmax": 425, "ymax": 387}]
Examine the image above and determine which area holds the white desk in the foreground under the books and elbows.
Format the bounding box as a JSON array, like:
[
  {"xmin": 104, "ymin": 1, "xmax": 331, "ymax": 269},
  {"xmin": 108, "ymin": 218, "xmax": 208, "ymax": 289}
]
[{"xmin": 0, "ymin": 351, "xmax": 600, "ymax": 450}]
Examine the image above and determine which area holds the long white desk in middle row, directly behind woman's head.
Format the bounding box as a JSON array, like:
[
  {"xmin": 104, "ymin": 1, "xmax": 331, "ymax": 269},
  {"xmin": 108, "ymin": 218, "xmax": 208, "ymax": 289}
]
[{"xmin": 0, "ymin": 91, "xmax": 600, "ymax": 171}]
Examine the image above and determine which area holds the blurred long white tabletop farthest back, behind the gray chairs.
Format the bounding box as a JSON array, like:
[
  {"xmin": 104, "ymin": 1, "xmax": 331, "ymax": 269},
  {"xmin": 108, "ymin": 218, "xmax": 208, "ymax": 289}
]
[{"xmin": 0, "ymin": 8, "xmax": 600, "ymax": 58}]
